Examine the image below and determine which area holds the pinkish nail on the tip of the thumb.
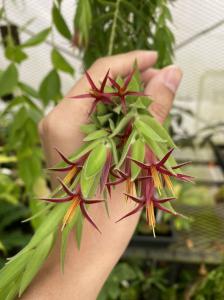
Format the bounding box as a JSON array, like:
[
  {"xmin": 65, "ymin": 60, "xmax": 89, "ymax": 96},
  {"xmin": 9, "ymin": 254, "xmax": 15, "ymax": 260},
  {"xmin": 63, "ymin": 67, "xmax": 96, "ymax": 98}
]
[{"xmin": 163, "ymin": 66, "xmax": 182, "ymax": 93}]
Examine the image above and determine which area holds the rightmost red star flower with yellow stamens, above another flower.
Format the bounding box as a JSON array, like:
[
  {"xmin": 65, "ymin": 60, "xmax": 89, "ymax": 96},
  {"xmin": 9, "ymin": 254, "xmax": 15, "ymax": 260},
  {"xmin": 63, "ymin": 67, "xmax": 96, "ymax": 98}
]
[{"xmin": 129, "ymin": 148, "xmax": 193, "ymax": 195}]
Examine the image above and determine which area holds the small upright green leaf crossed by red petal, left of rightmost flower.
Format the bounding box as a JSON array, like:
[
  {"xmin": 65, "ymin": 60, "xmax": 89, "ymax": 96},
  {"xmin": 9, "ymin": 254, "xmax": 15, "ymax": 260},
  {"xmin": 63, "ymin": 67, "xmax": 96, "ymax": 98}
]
[{"xmin": 131, "ymin": 139, "xmax": 145, "ymax": 181}]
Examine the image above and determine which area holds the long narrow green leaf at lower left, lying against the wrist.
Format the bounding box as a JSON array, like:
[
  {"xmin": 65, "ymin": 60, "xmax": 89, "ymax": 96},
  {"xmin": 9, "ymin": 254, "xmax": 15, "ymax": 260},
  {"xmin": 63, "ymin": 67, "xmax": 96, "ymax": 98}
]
[{"xmin": 19, "ymin": 234, "xmax": 54, "ymax": 297}]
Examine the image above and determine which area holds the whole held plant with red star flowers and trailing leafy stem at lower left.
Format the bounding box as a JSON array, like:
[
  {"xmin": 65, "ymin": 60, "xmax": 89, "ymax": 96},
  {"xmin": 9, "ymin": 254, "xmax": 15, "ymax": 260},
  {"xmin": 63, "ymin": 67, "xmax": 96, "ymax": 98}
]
[{"xmin": 0, "ymin": 66, "xmax": 193, "ymax": 295}]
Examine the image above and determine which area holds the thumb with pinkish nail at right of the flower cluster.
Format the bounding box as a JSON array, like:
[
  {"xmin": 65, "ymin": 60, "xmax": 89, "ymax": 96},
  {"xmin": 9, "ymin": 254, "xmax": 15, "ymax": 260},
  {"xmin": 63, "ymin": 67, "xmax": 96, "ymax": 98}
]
[{"xmin": 145, "ymin": 65, "xmax": 182, "ymax": 123}]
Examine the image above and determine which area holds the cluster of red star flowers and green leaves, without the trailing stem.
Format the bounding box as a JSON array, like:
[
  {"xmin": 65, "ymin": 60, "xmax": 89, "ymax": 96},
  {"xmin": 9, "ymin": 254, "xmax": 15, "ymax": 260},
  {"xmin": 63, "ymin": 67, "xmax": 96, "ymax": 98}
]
[{"xmin": 43, "ymin": 69, "xmax": 193, "ymax": 235}]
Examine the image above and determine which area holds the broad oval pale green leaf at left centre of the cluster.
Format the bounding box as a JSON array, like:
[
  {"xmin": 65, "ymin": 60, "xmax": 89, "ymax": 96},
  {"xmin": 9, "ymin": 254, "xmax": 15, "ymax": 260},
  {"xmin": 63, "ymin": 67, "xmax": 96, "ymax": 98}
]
[{"xmin": 83, "ymin": 143, "xmax": 107, "ymax": 178}]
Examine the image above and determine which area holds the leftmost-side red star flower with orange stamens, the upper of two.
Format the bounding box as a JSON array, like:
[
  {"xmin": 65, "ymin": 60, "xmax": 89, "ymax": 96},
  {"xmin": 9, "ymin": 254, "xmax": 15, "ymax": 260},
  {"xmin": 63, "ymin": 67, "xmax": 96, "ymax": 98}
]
[{"xmin": 48, "ymin": 148, "xmax": 87, "ymax": 188}]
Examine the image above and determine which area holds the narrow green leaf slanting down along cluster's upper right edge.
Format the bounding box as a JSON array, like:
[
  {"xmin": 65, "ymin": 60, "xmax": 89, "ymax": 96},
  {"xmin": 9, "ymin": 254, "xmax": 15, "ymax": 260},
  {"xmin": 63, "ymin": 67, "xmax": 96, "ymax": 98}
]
[{"xmin": 140, "ymin": 115, "xmax": 176, "ymax": 147}]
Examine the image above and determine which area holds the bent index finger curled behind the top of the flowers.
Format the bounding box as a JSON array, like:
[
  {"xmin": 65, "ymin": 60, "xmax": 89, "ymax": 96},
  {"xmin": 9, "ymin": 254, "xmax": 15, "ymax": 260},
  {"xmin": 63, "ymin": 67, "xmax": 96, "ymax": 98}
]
[{"xmin": 89, "ymin": 50, "xmax": 157, "ymax": 79}]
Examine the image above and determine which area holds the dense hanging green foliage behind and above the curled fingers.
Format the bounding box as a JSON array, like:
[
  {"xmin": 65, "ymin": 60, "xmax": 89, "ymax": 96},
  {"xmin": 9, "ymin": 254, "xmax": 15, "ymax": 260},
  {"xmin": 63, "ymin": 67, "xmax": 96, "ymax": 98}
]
[{"xmin": 73, "ymin": 0, "xmax": 174, "ymax": 67}]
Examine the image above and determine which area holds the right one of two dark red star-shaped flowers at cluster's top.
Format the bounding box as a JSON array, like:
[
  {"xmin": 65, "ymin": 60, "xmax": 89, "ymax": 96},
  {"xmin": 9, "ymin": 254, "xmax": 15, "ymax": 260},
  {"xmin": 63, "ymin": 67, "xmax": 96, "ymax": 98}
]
[{"xmin": 108, "ymin": 69, "xmax": 145, "ymax": 113}]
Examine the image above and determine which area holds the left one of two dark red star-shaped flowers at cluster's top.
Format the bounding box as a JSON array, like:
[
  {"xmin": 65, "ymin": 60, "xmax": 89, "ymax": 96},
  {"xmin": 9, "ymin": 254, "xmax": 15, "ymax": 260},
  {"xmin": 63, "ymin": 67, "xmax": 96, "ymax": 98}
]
[{"xmin": 71, "ymin": 70, "xmax": 112, "ymax": 115}]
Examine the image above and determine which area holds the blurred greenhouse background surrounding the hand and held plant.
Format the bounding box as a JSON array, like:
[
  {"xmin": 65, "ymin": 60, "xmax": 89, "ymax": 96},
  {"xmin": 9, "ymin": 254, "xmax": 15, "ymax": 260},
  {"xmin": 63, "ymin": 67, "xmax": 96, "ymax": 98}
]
[{"xmin": 0, "ymin": 0, "xmax": 224, "ymax": 300}]
